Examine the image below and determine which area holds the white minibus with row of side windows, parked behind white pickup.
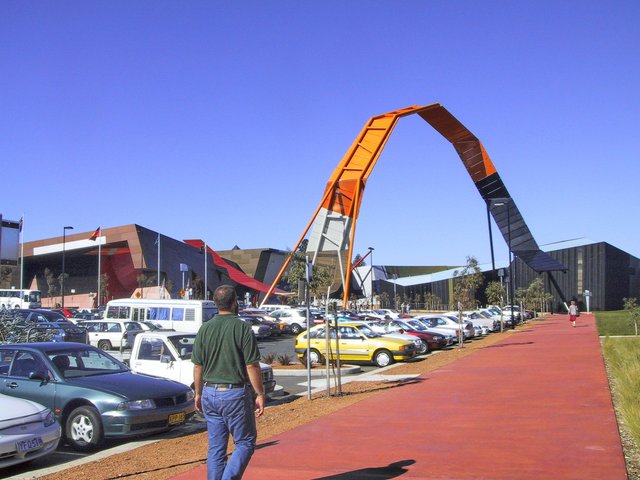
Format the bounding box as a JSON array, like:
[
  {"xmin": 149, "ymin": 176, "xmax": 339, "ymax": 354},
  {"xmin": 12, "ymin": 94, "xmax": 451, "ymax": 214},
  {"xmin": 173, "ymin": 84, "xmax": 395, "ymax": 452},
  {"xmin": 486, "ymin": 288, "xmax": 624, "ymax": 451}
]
[{"xmin": 104, "ymin": 298, "xmax": 218, "ymax": 332}]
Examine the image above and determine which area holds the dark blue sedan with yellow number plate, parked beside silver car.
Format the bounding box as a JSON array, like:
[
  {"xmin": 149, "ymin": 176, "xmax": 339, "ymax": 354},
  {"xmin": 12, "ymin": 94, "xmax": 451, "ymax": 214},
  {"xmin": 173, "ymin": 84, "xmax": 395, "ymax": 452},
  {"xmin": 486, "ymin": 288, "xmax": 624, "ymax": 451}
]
[{"xmin": 0, "ymin": 342, "xmax": 195, "ymax": 451}]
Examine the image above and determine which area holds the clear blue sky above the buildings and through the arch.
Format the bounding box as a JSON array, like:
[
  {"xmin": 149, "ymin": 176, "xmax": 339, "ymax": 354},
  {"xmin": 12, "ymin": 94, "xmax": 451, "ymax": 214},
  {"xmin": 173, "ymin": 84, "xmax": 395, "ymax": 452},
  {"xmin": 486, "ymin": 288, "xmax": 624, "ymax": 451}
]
[{"xmin": 0, "ymin": 0, "xmax": 640, "ymax": 265}]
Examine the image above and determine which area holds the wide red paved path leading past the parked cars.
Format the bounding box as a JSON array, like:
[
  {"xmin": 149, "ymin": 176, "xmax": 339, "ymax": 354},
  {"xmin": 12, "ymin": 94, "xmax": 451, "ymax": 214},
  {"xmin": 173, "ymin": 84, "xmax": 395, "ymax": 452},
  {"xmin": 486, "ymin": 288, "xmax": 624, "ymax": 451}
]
[{"xmin": 176, "ymin": 314, "xmax": 627, "ymax": 480}]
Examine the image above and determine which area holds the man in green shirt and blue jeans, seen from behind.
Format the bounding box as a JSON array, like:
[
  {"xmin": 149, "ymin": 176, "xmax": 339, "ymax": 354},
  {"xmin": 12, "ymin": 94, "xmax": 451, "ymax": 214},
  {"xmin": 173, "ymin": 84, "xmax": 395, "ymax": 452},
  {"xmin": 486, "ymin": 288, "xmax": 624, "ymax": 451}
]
[{"xmin": 191, "ymin": 285, "xmax": 265, "ymax": 480}]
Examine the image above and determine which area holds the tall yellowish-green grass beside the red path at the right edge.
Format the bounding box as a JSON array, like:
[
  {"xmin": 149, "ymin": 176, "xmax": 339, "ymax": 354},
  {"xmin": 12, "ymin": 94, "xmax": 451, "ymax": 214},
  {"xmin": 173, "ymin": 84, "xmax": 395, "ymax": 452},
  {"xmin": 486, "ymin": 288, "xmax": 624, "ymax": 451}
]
[{"xmin": 602, "ymin": 337, "xmax": 640, "ymax": 445}]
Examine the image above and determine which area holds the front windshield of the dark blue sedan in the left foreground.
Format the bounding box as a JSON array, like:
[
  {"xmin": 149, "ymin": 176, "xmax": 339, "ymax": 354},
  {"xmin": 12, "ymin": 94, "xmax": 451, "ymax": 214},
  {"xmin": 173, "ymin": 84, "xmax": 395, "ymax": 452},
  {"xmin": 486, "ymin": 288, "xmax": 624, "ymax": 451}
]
[{"xmin": 46, "ymin": 346, "xmax": 129, "ymax": 378}]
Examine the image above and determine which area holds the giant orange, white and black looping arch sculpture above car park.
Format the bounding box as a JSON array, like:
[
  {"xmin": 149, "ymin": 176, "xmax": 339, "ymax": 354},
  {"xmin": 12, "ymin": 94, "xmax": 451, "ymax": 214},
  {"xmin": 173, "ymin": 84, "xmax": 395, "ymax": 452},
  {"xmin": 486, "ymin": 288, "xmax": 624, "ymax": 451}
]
[{"xmin": 263, "ymin": 103, "xmax": 566, "ymax": 305}]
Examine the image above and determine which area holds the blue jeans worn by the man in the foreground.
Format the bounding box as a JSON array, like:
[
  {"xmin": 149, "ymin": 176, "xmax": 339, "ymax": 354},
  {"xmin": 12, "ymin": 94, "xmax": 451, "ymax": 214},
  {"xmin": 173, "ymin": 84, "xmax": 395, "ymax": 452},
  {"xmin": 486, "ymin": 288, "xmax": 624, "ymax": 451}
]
[{"xmin": 202, "ymin": 386, "xmax": 257, "ymax": 480}]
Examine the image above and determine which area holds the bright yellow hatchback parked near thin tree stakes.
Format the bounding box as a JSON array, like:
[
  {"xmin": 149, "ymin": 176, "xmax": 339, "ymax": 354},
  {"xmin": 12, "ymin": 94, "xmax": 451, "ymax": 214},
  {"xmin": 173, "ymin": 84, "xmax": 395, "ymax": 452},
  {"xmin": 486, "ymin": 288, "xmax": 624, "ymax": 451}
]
[{"xmin": 295, "ymin": 323, "xmax": 416, "ymax": 367}]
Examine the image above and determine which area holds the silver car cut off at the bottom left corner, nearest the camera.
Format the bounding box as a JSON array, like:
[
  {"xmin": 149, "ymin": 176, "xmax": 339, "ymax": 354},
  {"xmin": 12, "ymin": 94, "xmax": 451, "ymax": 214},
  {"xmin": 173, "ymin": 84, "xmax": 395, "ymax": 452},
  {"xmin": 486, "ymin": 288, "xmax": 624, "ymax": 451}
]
[{"xmin": 0, "ymin": 394, "xmax": 61, "ymax": 468}]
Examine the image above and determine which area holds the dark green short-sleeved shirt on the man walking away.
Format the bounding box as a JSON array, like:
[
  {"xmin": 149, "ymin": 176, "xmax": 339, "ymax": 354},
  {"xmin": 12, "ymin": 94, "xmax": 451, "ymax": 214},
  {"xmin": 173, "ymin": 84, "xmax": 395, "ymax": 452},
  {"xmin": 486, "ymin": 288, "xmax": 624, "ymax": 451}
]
[{"xmin": 191, "ymin": 314, "xmax": 260, "ymax": 383}]
